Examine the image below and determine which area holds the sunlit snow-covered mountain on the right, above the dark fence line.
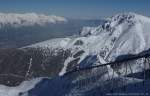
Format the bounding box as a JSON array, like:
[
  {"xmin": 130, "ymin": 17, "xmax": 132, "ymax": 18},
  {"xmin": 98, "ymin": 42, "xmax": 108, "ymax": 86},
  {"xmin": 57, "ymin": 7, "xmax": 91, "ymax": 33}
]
[{"xmin": 28, "ymin": 13, "xmax": 150, "ymax": 75}]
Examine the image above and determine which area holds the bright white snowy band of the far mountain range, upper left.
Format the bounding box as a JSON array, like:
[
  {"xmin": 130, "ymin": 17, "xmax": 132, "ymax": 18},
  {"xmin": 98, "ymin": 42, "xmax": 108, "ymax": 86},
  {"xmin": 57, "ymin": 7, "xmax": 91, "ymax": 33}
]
[{"xmin": 0, "ymin": 13, "xmax": 67, "ymax": 27}]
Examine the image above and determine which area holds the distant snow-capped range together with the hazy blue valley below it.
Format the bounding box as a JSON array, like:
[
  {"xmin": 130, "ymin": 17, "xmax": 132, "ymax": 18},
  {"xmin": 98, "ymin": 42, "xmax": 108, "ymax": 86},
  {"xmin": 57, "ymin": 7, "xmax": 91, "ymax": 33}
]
[{"xmin": 0, "ymin": 13, "xmax": 104, "ymax": 48}]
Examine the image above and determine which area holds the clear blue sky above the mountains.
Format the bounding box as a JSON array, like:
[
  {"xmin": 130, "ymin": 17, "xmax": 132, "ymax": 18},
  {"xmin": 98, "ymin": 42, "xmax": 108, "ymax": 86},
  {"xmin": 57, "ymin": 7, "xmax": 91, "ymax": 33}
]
[{"xmin": 0, "ymin": 0, "xmax": 150, "ymax": 18}]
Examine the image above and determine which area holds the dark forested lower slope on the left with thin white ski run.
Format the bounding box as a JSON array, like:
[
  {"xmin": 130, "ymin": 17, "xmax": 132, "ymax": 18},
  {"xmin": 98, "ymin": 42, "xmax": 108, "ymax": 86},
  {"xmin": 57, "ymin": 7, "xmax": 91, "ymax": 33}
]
[{"xmin": 0, "ymin": 48, "xmax": 70, "ymax": 86}]
